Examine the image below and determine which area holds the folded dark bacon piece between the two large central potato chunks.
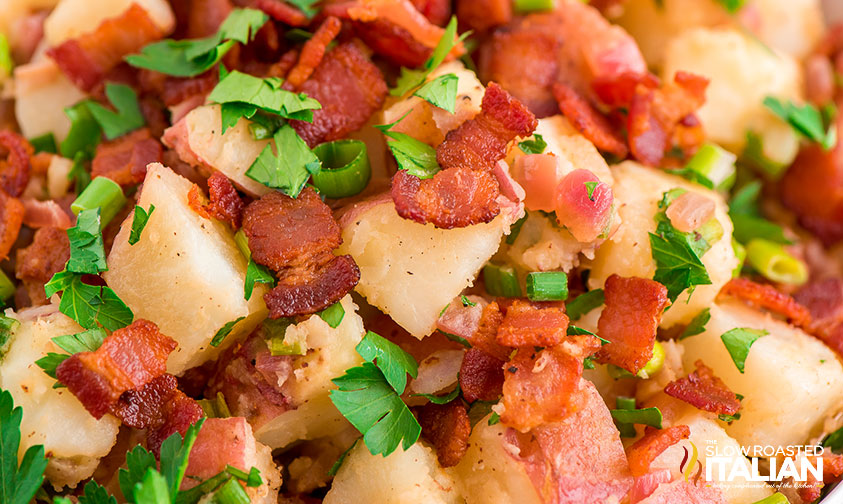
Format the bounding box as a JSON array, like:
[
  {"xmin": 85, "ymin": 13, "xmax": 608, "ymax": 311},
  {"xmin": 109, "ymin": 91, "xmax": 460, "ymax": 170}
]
[{"xmin": 243, "ymin": 188, "xmax": 360, "ymax": 318}]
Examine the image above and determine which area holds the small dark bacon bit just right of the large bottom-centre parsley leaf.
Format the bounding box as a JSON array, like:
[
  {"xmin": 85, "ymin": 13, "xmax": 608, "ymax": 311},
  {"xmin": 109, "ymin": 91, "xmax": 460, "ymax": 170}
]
[{"xmin": 416, "ymin": 401, "xmax": 471, "ymax": 467}]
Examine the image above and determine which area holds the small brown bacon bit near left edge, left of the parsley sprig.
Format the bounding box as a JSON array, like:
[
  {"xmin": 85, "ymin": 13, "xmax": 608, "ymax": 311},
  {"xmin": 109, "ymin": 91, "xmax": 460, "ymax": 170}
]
[{"xmin": 15, "ymin": 227, "xmax": 70, "ymax": 306}]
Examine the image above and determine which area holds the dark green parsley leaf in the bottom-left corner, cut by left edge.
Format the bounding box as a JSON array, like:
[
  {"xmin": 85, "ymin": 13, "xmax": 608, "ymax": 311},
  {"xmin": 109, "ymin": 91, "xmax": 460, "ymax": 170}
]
[{"xmin": 0, "ymin": 389, "xmax": 47, "ymax": 504}]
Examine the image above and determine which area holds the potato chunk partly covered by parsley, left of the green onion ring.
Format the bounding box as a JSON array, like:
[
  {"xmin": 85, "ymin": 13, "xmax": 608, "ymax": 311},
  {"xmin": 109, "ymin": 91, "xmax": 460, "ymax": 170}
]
[{"xmin": 164, "ymin": 105, "xmax": 271, "ymax": 197}]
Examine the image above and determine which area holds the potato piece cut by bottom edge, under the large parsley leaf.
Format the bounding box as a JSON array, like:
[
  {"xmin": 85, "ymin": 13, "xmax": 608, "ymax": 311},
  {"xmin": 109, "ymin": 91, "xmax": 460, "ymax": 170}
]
[{"xmin": 324, "ymin": 442, "xmax": 463, "ymax": 504}]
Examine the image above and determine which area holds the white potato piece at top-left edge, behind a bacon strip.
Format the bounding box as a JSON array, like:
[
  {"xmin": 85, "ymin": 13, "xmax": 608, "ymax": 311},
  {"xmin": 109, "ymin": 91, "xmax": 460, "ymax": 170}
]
[{"xmin": 44, "ymin": 0, "xmax": 176, "ymax": 46}]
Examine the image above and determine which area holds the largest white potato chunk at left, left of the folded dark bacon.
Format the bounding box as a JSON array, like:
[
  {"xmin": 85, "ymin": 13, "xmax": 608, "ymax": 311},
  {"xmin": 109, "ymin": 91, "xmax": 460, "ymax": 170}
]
[{"xmin": 103, "ymin": 163, "xmax": 266, "ymax": 374}]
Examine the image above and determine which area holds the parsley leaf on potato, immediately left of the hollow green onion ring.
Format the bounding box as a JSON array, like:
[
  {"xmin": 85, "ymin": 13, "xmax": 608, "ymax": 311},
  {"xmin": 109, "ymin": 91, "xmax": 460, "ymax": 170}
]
[{"xmin": 246, "ymin": 124, "xmax": 321, "ymax": 198}]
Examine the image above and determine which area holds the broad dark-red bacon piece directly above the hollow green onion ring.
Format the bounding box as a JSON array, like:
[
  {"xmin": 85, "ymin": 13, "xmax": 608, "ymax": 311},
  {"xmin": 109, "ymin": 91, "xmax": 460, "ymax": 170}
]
[{"xmin": 291, "ymin": 42, "xmax": 387, "ymax": 147}]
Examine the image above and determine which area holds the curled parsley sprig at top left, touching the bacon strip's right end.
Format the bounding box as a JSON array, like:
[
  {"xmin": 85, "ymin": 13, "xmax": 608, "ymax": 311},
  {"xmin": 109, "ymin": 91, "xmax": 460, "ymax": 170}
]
[{"xmin": 126, "ymin": 9, "xmax": 269, "ymax": 77}]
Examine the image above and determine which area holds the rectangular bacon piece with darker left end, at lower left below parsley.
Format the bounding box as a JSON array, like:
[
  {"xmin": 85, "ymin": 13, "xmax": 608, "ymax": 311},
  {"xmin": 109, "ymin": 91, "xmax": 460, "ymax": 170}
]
[{"xmin": 56, "ymin": 319, "xmax": 178, "ymax": 418}]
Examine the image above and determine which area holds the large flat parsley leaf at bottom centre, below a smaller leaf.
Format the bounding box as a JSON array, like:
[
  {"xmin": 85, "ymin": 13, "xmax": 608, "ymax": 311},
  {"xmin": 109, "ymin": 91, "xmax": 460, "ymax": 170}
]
[{"xmin": 330, "ymin": 362, "xmax": 421, "ymax": 456}]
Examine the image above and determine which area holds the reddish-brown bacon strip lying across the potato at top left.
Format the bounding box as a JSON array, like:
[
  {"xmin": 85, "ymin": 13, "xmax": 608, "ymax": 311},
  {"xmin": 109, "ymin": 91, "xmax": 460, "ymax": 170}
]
[{"xmin": 47, "ymin": 3, "xmax": 163, "ymax": 92}]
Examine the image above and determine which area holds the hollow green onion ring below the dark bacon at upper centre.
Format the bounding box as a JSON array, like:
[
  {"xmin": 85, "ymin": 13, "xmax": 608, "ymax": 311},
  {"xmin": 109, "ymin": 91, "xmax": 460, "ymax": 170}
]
[{"xmin": 313, "ymin": 140, "xmax": 372, "ymax": 198}]
